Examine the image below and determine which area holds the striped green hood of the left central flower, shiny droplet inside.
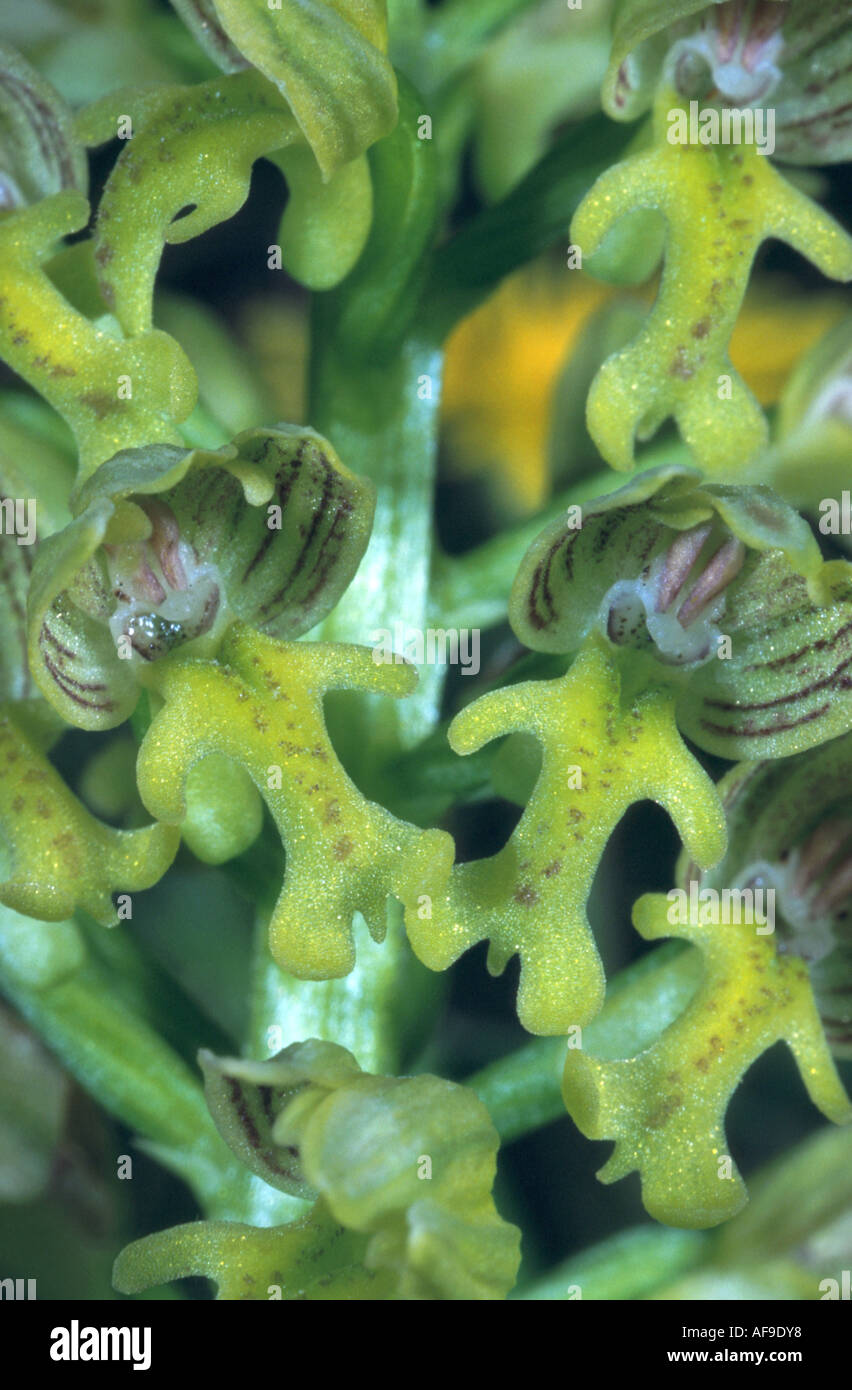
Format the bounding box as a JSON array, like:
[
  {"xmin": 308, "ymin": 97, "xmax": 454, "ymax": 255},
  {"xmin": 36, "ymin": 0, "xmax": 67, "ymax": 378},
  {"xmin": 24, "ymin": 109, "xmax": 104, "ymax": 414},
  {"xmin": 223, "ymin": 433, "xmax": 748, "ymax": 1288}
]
[{"xmin": 28, "ymin": 425, "xmax": 374, "ymax": 728}]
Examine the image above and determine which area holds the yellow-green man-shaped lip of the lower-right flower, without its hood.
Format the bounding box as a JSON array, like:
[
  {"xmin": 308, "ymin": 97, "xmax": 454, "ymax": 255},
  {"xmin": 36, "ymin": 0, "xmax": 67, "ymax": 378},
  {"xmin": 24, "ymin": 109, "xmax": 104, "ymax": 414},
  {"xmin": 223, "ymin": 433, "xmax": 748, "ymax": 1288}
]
[{"xmin": 563, "ymin": 894, "xmax": 852, "ymax": 1227}]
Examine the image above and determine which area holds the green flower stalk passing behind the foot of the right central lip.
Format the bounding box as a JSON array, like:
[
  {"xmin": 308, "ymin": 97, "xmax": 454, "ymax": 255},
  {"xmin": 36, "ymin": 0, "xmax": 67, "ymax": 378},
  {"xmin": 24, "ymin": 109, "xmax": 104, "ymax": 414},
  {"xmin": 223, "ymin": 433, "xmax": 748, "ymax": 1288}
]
[{"xmin": 467, "ymin": 942, "xmax": 702, "ymax": 1143}]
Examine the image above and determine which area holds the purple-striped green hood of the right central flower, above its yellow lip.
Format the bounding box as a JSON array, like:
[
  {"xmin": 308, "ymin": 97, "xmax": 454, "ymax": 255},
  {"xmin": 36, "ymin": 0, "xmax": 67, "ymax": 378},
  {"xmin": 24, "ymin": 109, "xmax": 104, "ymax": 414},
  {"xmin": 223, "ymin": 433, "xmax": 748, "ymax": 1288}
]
[{"xmin": 510, "ymin": 466, "xmax": 852, "ymax": 759}]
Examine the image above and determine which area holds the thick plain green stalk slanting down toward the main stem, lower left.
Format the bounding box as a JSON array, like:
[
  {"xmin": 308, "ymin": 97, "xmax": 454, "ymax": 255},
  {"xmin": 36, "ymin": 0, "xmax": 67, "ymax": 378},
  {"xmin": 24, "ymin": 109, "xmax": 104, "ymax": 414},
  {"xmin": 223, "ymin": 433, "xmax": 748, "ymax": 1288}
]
[{"xmin": 0, "ymin": 960, "xmax": 242, "ymax": 1216}]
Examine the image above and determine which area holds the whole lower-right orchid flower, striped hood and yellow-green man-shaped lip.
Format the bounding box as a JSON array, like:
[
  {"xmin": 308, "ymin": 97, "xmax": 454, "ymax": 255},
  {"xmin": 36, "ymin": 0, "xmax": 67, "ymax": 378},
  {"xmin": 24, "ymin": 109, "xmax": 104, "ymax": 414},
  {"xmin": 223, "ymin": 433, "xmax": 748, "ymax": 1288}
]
[{"xmin": 564, "ymin": 734, "xmax": 852, "ymax": 1226}]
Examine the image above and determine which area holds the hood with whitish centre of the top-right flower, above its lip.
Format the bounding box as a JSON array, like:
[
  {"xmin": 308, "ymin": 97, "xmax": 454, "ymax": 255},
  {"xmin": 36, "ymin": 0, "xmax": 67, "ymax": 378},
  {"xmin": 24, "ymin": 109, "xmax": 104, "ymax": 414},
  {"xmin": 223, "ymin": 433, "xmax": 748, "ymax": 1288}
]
[{"xmin": 602, "ymin": 0, "xmax": 852, "ymax": 164}]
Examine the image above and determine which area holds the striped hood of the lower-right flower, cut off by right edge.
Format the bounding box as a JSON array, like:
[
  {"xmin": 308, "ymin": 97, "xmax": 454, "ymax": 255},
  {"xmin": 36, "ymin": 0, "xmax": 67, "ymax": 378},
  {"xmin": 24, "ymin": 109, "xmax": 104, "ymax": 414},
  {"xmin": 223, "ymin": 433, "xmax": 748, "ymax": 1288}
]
[{"xmin": 677, "ymin": 734, "xmax": 852, "ymax": 1056}]
